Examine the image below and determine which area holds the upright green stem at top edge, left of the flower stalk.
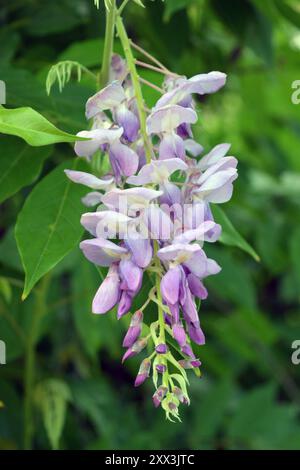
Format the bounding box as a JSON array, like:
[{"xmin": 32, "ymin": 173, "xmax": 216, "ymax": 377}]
[{"xmin": 99, "ymin": 0, "xmax": 116, "ymax": 88}]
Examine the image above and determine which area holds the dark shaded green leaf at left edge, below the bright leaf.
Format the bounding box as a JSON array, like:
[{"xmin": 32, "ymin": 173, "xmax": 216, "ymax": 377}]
[{"xmin": 0, "ymin": 137, "xmax": 52, "ymax": 203}]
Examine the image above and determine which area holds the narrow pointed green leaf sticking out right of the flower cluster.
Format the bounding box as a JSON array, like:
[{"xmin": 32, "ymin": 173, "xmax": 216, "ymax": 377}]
[{"xmin": 212, "ymin": 205, "xmax": 260, "ymax": 262}]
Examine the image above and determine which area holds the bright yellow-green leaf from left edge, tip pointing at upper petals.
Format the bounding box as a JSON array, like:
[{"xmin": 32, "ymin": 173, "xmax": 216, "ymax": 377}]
[{"xmin": 0, "ymin": 107, "xmax": 86, "ymax": 147}]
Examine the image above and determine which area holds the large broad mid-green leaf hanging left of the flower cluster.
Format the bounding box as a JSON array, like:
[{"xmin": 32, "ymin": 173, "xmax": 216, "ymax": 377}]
[{"xmin": 15, "ymin": 160, "xmax": 86, "ymax": 299}]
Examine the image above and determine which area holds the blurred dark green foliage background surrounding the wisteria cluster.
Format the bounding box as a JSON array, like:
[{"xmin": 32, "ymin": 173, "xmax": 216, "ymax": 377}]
[{"xmin": 0, "ymin": 0, "xmax": 300, "ymax": 449}]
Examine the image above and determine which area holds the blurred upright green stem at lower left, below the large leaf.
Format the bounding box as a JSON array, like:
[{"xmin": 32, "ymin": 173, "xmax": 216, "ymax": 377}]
[{"xmin": 24, "ymin": 276, "xmax": 49, "ymax": 450}]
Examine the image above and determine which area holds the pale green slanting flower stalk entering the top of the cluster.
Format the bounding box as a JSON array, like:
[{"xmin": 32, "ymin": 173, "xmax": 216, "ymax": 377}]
[{"xmin": 116, "ymin": 15, "xmax": 152, "ymax": 163}]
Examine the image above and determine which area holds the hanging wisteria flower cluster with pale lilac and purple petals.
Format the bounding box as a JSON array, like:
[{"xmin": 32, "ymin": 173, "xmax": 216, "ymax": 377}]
[{"xmin": 66, "ymin": 50, "xmax": 237, "ymax": 420}]
